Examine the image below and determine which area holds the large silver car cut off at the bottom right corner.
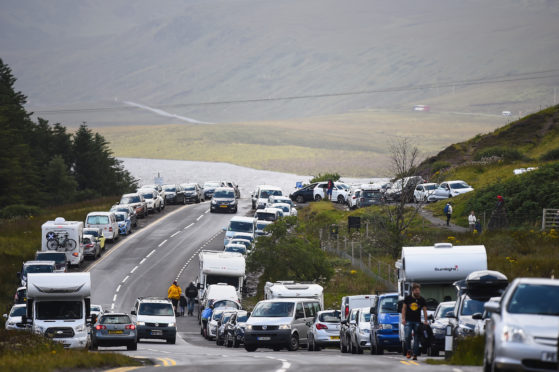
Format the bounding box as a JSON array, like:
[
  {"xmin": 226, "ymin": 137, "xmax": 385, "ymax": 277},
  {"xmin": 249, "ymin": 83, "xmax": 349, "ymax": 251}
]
[{"xmin": 483, "ymin": 278, "xmax": 559, "ymax": 371}]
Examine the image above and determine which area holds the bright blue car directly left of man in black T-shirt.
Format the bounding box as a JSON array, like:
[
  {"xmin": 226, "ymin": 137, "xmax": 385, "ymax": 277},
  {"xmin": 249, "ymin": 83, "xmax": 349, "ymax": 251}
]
[{"xmin": 371, "ymin": 293, "xmax": 402, "ymax": 355}]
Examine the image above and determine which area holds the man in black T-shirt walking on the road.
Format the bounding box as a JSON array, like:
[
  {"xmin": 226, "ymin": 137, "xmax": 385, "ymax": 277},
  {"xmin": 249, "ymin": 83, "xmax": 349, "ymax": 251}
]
[{"xmin": 402, "ymin": 283, "xmax": 429, "ymax": 360}]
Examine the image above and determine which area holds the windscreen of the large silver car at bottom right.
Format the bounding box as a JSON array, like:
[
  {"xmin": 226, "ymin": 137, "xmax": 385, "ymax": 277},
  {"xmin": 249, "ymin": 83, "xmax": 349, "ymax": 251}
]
[{"xmin": 507, "ymin": 283, "xmax": 559, "ymax": 316}]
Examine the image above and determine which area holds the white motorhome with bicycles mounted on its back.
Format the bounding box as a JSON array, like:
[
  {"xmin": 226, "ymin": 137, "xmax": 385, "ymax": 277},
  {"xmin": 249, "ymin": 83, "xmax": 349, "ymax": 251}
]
[{"xmin": 41, "ymin": 217, "xmax": 84, "ymax": 266}]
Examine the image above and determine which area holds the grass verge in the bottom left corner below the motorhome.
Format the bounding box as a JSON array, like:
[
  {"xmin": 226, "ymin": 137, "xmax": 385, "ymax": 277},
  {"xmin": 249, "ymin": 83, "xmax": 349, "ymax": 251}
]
[{"xmin": 0, "ymin": 329, "xmax": 142, "ymax": 372}]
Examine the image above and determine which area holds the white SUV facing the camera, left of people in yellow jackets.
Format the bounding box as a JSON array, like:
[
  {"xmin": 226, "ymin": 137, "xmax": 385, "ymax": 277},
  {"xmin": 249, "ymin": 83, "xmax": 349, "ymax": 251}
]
[{"xmin": 130, "ymin": 297, "xmax": 177, "ymax": 344}]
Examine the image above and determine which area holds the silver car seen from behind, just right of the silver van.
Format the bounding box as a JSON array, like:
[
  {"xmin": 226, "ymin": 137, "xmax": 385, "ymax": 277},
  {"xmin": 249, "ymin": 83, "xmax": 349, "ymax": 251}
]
[{"xmin": 307, "ymin": 310, "xmax": 341, "ymax": 351}]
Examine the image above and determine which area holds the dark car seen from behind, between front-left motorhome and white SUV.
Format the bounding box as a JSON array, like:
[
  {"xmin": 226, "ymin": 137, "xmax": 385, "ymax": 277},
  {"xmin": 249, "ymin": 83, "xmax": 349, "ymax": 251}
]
[{"xmin": 91, "ymin": 313, "xmax": 138, "ymax": 350}]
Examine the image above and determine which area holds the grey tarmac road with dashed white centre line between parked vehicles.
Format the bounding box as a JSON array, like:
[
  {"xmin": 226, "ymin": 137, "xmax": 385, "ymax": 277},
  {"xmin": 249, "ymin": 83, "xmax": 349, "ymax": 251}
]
[{"xmin": 86, "ymin": 199, "xmax": 481, "ymax": 372}]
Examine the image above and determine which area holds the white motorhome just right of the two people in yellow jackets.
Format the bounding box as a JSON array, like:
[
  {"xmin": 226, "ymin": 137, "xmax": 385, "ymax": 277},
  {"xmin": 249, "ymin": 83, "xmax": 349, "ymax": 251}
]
[{"xmin": 198, "ymin": 250, "xmax": 246, "ymax": 298}]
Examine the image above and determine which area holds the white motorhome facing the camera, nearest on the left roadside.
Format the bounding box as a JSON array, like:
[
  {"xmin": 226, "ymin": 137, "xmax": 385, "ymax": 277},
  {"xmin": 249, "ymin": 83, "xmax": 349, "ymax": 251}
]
[{"xmin": 26, "ymin": 273, "xmax": 91, "ymax": 349}]
